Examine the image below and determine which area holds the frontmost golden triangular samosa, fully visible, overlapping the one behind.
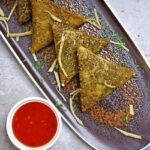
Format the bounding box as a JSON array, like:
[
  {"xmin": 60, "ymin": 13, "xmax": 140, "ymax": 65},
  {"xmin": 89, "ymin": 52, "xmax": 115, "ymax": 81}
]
[{"xmin": 77, "ymin": 46, "xmax": 135, "ymax": 111}]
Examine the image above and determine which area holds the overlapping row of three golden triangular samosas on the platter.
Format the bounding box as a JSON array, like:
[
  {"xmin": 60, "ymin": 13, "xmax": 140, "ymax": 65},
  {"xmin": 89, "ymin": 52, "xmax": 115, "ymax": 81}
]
[{"xmin": 19, "ymin": 0, "xmax": 134, "ymax": 111}]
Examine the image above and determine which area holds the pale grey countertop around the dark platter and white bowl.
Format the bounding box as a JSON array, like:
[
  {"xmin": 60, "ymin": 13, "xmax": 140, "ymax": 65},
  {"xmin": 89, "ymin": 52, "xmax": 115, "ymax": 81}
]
[{"xmin": 0, "ymin": 0, "xmax": 150, "ymax": 150}]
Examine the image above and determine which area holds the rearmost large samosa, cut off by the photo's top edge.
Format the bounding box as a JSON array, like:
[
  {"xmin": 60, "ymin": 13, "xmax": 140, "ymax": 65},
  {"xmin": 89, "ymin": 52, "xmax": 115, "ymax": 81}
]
[{"xmin": 31, "ymin": 0, "xmax": 86, "ymax": 53}]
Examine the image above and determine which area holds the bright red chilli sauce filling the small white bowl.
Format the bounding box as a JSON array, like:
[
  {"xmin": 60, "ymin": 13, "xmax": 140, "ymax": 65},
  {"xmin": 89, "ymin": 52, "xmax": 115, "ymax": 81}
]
[{"xmin": 12, "ymin": 102, "xmax": 57, "ymax": 147}]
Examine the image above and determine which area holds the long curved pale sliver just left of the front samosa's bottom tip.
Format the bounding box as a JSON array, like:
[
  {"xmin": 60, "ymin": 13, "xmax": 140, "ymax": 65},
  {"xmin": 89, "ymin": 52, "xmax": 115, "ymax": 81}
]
[{"xmin": 70, "ymin": 92, "xmax": 83, "ymax": 126}]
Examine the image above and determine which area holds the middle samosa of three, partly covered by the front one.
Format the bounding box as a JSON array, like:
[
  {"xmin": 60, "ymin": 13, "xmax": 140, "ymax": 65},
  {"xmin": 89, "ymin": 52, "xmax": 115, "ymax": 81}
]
[{"xmin": 53, "ymin": 24, "xmax": 109, "ymax": 85}]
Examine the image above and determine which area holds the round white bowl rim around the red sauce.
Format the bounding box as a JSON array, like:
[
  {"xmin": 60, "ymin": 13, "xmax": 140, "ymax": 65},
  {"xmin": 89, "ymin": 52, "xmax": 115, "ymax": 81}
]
[{"xmin": 6, "ymin": 97, "xmax": 62, "ymax": 150}]
